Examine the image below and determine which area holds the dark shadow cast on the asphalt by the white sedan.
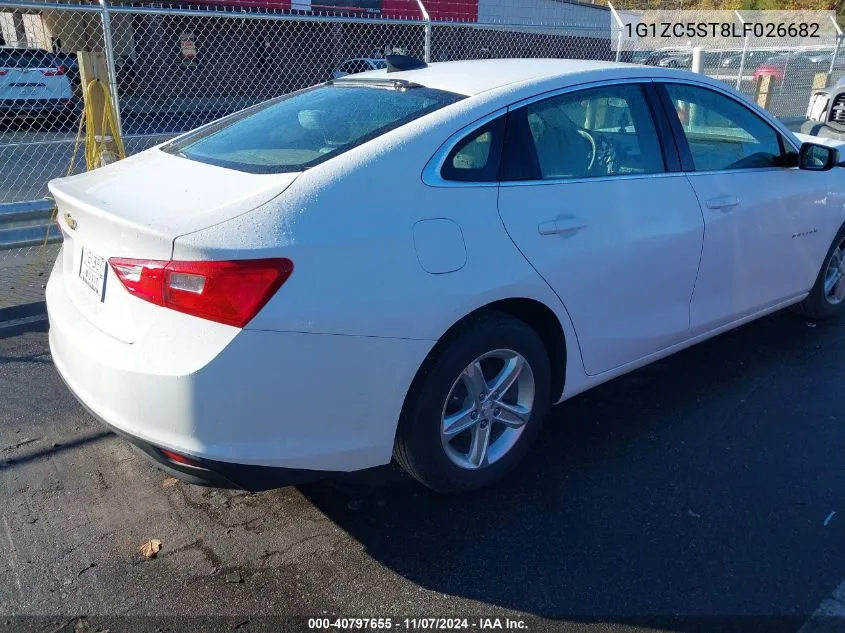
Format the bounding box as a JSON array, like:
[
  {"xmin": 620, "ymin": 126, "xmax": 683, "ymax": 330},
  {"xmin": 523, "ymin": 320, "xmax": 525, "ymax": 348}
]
[{"xmin": 301, "ymin": 313, "xmax": 845, "ymax": 630}]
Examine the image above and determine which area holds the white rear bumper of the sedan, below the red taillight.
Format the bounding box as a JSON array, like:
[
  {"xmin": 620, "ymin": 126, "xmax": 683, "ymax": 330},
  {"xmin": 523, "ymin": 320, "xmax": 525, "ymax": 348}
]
[{"xmin": 46, "ymin": 257, "xmax": 433, "ymax": 489}]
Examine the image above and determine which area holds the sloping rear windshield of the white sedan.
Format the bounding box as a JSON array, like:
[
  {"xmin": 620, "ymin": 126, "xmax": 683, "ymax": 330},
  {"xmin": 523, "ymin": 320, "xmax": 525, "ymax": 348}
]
[{"xmin": 163, "ymin": 81, "xmax": 463, "ymax": 174}]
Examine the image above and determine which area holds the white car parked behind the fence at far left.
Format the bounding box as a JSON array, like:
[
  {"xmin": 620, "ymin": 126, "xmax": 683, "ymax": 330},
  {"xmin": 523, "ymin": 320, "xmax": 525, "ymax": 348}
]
[{"xmin": 0, "ymin": 47, "xmax": 78, "ymax": 124}]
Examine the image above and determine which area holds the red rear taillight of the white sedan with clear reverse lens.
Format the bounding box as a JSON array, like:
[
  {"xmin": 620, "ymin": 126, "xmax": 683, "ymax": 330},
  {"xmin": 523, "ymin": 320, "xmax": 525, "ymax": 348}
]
[{"xmin": 109, "ymin": 257, "xmax": 293, "ymax": 327}]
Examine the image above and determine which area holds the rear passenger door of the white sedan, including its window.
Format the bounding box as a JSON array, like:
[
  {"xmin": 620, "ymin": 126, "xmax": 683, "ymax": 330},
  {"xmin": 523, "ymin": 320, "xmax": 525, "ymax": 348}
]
[{"xmin": 499, "ymin": 81, "xmax": 703, "ymax": 375}]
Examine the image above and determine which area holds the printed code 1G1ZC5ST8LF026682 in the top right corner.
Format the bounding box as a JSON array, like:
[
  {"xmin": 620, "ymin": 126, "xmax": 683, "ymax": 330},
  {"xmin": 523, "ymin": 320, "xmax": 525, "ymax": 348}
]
[{"xmin": 625, "ymin": 22, "xmax": 822, "ymax": 39}]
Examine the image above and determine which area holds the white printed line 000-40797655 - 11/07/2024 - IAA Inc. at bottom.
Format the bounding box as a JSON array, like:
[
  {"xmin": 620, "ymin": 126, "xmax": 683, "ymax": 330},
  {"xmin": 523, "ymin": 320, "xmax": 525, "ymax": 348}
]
[{"xmin": 308, "ymin": 617, "xmax": 528, "ymax": 631}]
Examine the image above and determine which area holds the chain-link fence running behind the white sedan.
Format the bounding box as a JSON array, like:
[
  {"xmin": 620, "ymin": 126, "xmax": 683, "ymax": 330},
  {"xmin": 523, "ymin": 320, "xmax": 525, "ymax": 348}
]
[{"xmin": 0, "ymin": 0, "xmax": 845, "ymax": 312}]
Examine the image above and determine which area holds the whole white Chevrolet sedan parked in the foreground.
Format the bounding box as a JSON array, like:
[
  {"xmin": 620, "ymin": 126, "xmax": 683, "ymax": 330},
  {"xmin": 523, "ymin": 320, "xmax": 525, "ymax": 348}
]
[{"xmin": 47, "ymin": 57, "xmax": 845, "ymax": 492}]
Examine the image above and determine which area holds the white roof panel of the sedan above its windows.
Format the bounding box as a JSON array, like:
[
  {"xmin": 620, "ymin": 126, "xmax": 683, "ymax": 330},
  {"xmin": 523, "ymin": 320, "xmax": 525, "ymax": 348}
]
[{"xmin": 356, "ymin": 59, "xmax": 653, "ymax": 96}]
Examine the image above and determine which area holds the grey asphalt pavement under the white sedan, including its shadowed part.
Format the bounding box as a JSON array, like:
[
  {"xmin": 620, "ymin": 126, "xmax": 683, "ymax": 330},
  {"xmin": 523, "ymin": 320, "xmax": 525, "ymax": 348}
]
[{"xmin": 0, "ymin": 313, "xmax": 845, "ymax": 633}]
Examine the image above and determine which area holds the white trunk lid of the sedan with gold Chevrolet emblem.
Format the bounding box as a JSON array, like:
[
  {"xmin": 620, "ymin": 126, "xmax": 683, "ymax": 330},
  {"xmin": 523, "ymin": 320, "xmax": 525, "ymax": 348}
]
[{"xmin": 50, "ymin": 149, "xmax": 298, "ymax": 343}]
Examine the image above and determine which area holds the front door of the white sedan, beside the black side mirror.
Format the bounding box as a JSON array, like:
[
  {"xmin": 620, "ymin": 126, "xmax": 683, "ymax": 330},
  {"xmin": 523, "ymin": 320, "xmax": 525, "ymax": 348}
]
[{"xmin": 657, "ymin": 82, "xmax": 828, "ymax": 330}]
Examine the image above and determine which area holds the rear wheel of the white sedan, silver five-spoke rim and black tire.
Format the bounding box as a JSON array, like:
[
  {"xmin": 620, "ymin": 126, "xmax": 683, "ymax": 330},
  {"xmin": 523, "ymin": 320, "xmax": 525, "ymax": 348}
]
[{"xmin": 394, "ymin": 312, "xmax": 551, "ymax": 493}]
